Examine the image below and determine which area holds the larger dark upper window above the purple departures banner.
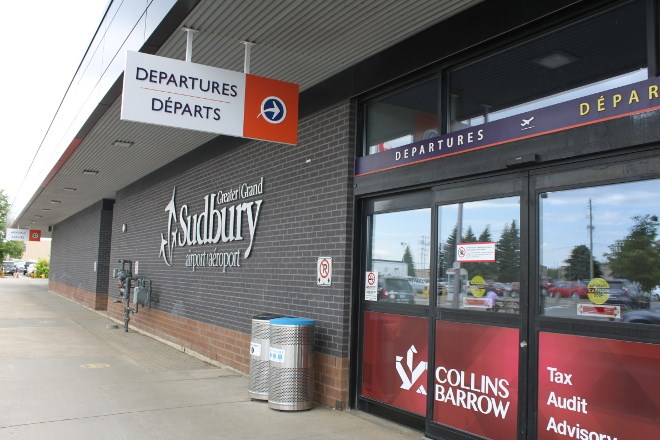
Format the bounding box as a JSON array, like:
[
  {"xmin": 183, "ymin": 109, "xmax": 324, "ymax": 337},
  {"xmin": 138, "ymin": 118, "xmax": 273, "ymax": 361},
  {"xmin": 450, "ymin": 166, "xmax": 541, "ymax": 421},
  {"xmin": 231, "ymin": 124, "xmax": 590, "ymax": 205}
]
[{"xmin": 449, "ymin": 1, "xmax": 648, "ymax": 131}]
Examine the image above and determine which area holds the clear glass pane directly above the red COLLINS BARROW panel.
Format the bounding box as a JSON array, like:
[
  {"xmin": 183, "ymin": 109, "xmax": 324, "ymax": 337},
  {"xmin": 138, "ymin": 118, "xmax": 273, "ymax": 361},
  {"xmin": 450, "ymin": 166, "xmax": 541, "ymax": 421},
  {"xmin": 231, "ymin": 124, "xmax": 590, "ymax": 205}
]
[{"xmin": 437, "ymin": 196, "xmax": 520, "ymax": 313}]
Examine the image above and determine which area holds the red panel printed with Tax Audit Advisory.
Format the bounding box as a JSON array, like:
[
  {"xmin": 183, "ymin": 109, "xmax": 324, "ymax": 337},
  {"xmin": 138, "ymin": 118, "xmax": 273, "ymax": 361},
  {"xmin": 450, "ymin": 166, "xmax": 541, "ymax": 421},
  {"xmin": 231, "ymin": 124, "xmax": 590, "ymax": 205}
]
[{"xmin": 537, "ymin": 333, "xmax": 660, "ymax": 440}]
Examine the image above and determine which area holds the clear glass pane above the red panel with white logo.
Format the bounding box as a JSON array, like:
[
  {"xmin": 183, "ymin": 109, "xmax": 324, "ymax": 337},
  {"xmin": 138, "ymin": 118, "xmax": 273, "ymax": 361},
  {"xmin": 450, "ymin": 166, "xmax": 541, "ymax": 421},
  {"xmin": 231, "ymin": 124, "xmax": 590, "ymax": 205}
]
[{"xmin": 367, "ymin": 208, "xmax": 431, "ymax": 305}]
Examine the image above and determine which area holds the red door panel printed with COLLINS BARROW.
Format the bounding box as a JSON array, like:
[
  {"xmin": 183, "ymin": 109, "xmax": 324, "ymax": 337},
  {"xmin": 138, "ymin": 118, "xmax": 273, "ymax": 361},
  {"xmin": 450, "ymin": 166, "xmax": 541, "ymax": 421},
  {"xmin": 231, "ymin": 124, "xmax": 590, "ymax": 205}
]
[{"xmin": 433, "ymin": 321, "xmax": 519, "ymax": 440}]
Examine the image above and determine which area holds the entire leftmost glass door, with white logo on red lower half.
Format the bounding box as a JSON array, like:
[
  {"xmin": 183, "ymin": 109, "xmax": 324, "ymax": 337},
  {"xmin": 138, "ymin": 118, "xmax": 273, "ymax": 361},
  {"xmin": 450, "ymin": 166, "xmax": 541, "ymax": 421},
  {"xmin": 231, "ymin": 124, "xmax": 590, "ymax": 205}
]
[{"xmin": 358, "ymin": 191, "xmax": 432, "ymax": 430}]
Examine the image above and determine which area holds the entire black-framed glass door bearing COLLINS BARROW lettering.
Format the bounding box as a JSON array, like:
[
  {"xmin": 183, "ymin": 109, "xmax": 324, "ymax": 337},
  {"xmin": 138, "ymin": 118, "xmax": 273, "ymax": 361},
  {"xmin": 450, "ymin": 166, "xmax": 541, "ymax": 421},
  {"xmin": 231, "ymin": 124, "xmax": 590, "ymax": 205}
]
[{"xmin": 427, "ymin": 174, "xmax": 528, "ymax": 440}]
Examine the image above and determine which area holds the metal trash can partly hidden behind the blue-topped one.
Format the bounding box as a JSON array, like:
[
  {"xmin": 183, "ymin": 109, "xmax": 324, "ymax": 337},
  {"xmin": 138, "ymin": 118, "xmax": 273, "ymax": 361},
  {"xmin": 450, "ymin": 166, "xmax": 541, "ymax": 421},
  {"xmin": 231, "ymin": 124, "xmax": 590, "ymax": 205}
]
[{"xmin": 248, "ymin": 313, "xmax": 282, "ymax": 400}]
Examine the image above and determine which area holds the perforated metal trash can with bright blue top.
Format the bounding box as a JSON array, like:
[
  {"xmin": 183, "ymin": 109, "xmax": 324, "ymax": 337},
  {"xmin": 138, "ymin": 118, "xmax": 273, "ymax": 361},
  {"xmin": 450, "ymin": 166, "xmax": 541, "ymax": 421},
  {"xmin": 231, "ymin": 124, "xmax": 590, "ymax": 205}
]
[{"xmin": 268, "ymin": 318, "xmax": 315, "ymax": 411}]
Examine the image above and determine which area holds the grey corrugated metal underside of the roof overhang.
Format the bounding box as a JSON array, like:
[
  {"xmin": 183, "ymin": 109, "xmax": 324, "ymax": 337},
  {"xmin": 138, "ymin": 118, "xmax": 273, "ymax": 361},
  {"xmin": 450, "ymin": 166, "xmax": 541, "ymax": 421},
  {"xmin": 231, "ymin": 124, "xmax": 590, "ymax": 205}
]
[{"xmin": 20, "ymin": 0, "xmax": 481, "ymax": 224}]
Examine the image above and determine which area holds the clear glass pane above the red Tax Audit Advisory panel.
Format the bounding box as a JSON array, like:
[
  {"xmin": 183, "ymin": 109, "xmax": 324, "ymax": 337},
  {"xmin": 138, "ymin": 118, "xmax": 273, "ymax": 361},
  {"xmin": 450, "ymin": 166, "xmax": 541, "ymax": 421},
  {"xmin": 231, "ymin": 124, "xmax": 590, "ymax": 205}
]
[{"xmin": 539, "ymin": 180, "xmax": 660, "ymax": 324}]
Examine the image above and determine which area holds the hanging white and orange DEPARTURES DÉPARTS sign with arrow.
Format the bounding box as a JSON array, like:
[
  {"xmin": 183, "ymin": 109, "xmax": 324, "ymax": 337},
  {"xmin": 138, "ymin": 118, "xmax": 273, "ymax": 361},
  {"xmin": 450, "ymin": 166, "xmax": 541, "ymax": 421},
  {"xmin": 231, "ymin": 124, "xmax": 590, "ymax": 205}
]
[{"xmin": 121, "ymin": 51, "xmax": 298, "ymax": 144}]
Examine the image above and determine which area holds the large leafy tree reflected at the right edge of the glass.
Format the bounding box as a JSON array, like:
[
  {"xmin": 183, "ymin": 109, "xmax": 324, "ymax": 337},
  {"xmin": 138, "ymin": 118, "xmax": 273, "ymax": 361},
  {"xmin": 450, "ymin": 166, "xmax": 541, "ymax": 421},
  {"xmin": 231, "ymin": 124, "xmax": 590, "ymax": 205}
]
[{"xmin": 605, "ymin": 214, "xmax": 660, "ymax": 291}]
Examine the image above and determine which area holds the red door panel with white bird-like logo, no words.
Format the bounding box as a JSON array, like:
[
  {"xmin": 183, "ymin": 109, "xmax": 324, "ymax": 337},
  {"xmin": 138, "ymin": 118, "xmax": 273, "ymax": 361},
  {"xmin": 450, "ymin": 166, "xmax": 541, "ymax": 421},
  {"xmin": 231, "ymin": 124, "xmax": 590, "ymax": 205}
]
[{"xmin": 361, "ymin": 312, "xmax": 429, "ymax": 415}]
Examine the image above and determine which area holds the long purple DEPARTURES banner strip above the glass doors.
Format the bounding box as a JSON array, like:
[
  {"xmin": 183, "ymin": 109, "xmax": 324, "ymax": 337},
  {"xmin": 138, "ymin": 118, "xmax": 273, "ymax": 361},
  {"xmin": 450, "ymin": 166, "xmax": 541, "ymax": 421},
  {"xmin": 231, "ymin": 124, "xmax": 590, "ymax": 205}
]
[{"xmin": 355, "ymin": 78, "xmax": 660, "ymax": 176}]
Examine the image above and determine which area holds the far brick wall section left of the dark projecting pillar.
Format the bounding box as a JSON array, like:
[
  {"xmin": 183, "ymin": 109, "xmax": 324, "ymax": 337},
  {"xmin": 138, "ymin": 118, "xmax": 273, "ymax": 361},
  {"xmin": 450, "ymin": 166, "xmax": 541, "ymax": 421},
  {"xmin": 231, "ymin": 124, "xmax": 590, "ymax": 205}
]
[{"xmin": 48, "ymin": 200, "xmax": 112, "ymax": 310}]
